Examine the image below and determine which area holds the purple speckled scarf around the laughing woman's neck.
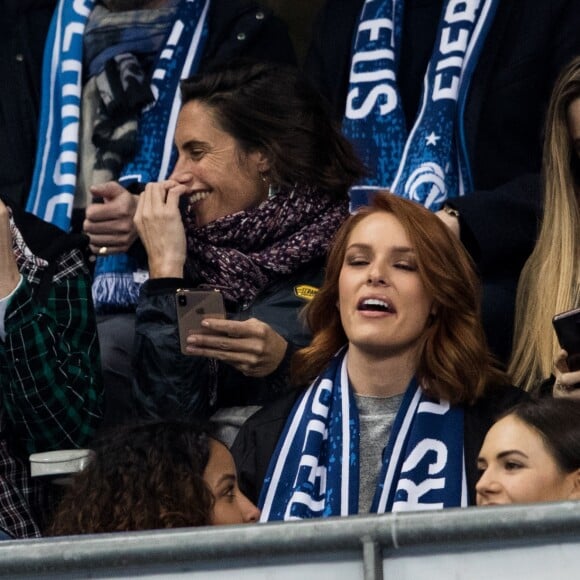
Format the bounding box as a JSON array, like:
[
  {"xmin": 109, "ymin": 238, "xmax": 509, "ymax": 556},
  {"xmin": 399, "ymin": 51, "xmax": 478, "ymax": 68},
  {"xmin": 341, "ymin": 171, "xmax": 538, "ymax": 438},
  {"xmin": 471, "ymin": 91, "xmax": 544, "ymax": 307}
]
[{"xmin": 184, "ymin": 189, "xmax": 348, "ymax": 309}]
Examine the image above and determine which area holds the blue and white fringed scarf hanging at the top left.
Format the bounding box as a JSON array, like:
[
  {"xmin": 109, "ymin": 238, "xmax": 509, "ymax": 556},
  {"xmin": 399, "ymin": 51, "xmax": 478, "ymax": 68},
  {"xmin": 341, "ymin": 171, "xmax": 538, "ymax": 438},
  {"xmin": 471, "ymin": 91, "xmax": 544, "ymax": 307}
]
[{"xmin": 27, "ymin": 0, "xmax": 210, "ymax": 312}]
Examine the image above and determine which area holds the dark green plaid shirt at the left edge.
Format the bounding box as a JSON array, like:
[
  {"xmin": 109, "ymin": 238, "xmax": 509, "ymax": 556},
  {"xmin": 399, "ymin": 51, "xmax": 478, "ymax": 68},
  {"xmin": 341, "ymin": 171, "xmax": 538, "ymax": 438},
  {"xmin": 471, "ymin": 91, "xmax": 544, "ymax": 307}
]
[{"xmin": 0, "ymin": 273, "xmax": 101, "ymax": 453}]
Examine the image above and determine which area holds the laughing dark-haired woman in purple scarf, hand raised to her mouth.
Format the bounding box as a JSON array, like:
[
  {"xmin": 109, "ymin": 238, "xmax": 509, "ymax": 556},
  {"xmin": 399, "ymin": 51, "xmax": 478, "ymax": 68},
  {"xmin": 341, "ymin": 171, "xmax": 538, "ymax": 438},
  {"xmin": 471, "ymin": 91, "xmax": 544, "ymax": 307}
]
[{"xmin": 135, "ymin": 64, "xmax": 362, "ymax": 426}]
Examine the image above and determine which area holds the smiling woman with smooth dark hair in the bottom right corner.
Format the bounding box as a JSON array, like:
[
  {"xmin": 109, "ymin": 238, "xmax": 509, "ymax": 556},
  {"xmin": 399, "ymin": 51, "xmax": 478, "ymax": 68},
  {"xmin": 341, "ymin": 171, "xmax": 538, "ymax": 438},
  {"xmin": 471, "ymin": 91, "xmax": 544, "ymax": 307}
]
[{"xmin": 476, "ymin": 399, "xmax": 580, "ymax": 505}]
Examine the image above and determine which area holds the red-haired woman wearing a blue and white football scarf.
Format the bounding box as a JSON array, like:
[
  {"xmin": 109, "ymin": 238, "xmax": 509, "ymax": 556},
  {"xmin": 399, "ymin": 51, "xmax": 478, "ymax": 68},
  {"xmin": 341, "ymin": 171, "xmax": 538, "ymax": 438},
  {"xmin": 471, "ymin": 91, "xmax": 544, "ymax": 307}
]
[{"xmin": 232, "ymin": 193, "xmax": 523, "ymax": 520}]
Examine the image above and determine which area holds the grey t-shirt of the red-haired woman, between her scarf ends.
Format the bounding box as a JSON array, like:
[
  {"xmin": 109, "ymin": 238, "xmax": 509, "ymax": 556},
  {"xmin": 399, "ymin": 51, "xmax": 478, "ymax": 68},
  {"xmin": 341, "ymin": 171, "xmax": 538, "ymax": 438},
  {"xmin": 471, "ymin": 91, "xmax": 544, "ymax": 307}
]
[{"xmin": 354, "ymin": 393, "xmax": 404, "ymax": 514}]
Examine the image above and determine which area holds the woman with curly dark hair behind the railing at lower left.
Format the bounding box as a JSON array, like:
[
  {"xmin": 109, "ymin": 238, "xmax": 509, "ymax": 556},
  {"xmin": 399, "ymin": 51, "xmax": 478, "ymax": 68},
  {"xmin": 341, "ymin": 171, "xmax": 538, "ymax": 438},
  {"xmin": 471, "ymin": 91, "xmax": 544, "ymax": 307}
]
[{"xmin": 46, "ymin": 421, "xmax": 259, "ymax": 536}]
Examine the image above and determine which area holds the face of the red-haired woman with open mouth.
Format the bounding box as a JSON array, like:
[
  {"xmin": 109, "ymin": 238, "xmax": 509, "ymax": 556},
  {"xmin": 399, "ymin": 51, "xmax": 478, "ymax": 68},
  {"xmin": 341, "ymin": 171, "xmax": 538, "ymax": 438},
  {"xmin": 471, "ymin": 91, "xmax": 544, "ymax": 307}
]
[{"xmin": 339, "ymin": 212, "xmax": 432, "ymax": 357}]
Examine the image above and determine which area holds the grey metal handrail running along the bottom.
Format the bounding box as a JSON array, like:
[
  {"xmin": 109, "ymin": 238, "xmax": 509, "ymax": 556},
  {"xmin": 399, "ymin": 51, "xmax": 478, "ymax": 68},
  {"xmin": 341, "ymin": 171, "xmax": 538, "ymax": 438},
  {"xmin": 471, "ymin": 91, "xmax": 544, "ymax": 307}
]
[{"xmin": 0, "ymin": 501, "xmax": 580, "ymax": 580}]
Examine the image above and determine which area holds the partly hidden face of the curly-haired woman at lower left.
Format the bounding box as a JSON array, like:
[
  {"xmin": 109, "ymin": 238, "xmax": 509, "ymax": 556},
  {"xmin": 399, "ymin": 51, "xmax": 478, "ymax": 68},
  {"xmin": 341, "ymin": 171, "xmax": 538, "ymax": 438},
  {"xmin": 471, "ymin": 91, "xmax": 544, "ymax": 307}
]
[{"xmin": 203, "ymin": 439, "xmax": 260, "ymax": 526}]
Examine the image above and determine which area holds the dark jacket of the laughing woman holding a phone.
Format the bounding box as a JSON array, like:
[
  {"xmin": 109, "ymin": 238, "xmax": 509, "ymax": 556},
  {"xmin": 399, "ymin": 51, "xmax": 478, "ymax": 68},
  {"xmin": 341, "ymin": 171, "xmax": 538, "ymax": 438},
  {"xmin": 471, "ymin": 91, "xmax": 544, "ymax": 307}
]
[{"xmin": 133, "ymin": 260, "xmax": 323, "ymax": 419}]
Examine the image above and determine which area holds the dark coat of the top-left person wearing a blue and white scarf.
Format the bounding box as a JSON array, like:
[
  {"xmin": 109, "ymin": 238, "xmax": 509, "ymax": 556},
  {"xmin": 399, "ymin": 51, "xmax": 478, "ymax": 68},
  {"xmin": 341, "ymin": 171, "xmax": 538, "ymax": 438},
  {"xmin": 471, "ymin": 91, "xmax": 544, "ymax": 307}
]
[{"xmin": 0, "ymin": 0, "xmax": 296, "ymax": 208}]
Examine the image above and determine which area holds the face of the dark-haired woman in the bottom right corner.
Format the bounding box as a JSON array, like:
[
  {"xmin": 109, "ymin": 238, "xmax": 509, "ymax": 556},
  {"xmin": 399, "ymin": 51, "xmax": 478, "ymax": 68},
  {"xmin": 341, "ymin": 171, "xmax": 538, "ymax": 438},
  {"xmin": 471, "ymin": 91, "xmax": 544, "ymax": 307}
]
[{"xmin": 476, "ymin": 415, "xmax": 576, "ymax": 505}]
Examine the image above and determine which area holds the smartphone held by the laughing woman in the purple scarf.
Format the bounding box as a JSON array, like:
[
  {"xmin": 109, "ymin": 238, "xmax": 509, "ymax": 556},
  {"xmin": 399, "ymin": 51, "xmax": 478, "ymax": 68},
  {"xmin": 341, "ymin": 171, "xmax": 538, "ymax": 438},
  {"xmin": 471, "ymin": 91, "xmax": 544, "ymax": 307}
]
[{"xmin": 175, "ymin": 288, "xmax": 226, "ymax": 354}]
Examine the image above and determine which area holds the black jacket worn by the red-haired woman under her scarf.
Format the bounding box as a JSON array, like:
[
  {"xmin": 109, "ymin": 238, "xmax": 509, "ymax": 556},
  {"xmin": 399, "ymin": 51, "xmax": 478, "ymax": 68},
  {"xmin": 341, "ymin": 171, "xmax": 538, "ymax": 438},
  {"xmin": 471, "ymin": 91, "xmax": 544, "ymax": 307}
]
[{"xmin": 231, "ymin": 380, "xmax": 528, "ymax": 505}]
